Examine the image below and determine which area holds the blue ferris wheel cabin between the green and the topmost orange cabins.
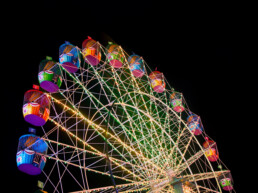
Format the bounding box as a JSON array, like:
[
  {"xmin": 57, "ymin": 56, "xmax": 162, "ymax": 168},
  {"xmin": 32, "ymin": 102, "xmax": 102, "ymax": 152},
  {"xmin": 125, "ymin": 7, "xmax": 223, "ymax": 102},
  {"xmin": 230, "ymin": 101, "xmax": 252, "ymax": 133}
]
[{"xmin": 59, "ymin": 42, "xmax": 80, "ymax": 73}]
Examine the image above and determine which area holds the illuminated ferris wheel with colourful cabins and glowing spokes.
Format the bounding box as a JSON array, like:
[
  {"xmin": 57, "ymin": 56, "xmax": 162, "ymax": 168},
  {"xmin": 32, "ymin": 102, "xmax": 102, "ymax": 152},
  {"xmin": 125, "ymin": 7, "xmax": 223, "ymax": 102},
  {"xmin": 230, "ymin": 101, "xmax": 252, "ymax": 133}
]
[{"xmin": 16, "ymin": 37, "xmax": 235, "ymax": 193}]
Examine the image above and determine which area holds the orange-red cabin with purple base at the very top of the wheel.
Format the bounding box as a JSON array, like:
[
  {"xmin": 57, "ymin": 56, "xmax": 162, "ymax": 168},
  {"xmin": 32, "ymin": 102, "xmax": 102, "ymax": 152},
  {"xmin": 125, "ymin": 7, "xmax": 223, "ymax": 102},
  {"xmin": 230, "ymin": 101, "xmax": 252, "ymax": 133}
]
[{"xmin": 82, "ymin": 37, "xmax": 101, "ymax": 66}]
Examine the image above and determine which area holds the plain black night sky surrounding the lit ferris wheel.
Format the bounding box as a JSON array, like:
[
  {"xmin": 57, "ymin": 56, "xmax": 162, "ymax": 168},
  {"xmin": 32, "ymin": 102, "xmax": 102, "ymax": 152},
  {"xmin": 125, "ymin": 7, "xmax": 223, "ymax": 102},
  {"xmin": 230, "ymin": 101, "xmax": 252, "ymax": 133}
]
[{"xmin": 1, "ymin": 0, "xmax": 258, "ymax": 193}]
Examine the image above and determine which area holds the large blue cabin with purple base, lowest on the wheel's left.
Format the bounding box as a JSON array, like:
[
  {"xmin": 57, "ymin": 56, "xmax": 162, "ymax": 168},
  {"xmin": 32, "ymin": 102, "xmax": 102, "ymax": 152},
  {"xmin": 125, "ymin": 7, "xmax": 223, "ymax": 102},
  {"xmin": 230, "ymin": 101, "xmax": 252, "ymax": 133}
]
[{"xmin": 16, "ymin": 134, "xmax": 48, "ymax": 175}]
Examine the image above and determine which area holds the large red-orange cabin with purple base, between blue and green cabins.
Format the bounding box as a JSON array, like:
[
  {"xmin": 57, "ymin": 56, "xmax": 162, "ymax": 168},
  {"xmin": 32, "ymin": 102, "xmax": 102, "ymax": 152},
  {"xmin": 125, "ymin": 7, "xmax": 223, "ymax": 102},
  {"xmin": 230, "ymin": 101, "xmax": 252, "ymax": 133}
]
[{"xmin": 22, "ymin": 89, "xmax": 50, "ymax": 126}]
